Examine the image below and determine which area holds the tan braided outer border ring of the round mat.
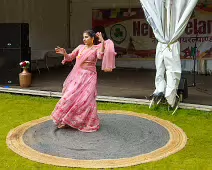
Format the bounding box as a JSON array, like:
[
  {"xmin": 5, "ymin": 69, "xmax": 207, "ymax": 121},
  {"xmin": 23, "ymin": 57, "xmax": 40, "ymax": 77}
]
[{"xmin": 6, "ymin": 110, "xmax": 187, "ymax": 168}]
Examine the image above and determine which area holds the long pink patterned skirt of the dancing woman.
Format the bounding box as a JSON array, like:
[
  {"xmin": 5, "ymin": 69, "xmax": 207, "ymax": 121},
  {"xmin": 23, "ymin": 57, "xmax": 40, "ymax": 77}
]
[{"xmin": 52, "ymin": 68, "xmax": 100, "ymax": 132}]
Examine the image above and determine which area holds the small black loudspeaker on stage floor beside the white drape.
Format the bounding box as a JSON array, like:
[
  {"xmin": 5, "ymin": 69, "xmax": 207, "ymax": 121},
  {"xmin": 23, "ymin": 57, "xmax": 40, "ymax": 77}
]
[{"xmin": 177, "ymin": 78, "xmax": 188, "ymax": 101}]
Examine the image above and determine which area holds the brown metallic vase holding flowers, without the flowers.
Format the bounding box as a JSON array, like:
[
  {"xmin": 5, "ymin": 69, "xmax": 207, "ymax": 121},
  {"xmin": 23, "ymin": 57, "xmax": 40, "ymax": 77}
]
[{"xmin": 19, "ymin": 68, "xmax": 32, "ymax": 88}]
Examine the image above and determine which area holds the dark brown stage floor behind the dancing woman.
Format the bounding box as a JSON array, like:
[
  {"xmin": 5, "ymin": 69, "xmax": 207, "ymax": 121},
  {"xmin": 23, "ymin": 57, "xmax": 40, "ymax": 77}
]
[{"xmin": 2, "ymin": 66, "xmax": 212, "ymax": 105}]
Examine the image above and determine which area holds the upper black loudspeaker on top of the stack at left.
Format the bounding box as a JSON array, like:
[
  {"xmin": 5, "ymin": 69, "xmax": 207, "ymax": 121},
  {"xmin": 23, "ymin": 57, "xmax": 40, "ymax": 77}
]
[{"xmin": 0, "ymin": 23, "xmax": 29, "ymax": 48}]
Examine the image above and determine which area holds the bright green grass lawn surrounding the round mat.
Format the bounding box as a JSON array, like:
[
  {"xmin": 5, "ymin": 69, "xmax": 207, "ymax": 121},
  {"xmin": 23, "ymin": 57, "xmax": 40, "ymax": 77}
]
[{"xmin": 0, "ymin": 93, "xmax": 212, "ymax": 170}]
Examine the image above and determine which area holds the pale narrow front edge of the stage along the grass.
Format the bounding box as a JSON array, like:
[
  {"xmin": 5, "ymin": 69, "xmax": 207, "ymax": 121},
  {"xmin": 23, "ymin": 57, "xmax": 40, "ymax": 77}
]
[{"xmin": 0, "ymin": 87, "xmax": 212, "ymax": 111}]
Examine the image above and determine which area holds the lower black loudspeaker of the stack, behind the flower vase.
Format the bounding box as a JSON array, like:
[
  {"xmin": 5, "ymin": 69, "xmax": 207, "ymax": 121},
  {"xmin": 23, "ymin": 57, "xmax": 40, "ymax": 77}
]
[{"xmin": 0, "ymin": 48, "xmax": 31, "ymax": 85}]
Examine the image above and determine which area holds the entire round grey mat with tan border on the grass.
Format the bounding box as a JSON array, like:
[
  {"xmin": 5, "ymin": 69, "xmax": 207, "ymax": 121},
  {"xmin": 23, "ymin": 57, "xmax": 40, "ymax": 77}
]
[{"xmin": 7, "ymin": 111, "xmax": 187, "ymax": 168}]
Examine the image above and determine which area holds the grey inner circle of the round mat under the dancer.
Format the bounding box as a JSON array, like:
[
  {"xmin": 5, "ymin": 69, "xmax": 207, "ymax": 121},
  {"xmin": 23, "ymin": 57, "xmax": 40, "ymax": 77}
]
[{"xmin": 23, "ymin": 114, "xmax": 170, "ymax": 160}]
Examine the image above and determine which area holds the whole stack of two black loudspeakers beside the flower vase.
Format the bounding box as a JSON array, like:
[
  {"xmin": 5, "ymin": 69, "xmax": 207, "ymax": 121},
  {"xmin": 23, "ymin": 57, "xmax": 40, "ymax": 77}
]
[{"xmin": 0, "ymin": 23, "xmax": 31, "ymax": 85}]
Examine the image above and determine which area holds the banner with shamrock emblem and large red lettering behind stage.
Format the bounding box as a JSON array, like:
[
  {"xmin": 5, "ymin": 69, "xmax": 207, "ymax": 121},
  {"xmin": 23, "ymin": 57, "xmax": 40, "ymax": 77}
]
[{"xmin": 92, "ymin": 4, "xmax": 212, "ymax": 59}]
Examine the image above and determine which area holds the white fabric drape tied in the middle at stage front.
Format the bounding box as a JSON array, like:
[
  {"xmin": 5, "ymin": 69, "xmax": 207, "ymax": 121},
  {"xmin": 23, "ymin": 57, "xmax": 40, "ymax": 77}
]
[{"xmin": 140, "ymin": 0, "xmax": 198, "ymax": 106}]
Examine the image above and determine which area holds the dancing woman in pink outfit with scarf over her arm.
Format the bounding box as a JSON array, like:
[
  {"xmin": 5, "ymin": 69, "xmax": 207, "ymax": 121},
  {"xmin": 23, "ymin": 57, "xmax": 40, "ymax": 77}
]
[{"xmin": 52, "ymin": 30, "xmax": 116, "ymax": 132}]
